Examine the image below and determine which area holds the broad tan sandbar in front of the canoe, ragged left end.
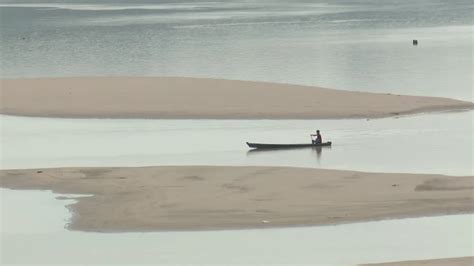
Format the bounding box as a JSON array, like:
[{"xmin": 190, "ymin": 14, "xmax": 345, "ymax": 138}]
[{"xmin": 0, "ymin": 166, "xmax": 474, "ymax": 232}]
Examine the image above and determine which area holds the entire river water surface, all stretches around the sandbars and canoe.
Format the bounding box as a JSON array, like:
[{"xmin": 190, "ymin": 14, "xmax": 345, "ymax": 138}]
[{"xmin": 0, "ymin": 0, "xmax": 474, "ymax": 265}]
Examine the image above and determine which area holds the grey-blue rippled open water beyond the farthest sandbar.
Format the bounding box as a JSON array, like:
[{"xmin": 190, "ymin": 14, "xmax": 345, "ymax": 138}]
[{"xmin": 0, "ymin": 0, "xmax": 474, "ymax": 101}]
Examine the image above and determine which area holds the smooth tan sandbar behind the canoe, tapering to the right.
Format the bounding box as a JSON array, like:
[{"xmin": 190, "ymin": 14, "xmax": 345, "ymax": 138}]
[{"xmin": 0, "ymin": 77, "xmax": 474, "ymax": 119}]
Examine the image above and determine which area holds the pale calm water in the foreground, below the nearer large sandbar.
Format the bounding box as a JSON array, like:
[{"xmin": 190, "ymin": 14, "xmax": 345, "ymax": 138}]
[{"xmin": 0, "ymin": 189, "xmax": 474, "ymax": 265}]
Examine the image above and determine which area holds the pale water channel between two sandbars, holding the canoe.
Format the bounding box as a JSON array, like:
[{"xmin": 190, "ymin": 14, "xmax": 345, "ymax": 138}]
[{"xmin": 0, "ymin": 111, "xmax": 474, "ymax": 175}]
